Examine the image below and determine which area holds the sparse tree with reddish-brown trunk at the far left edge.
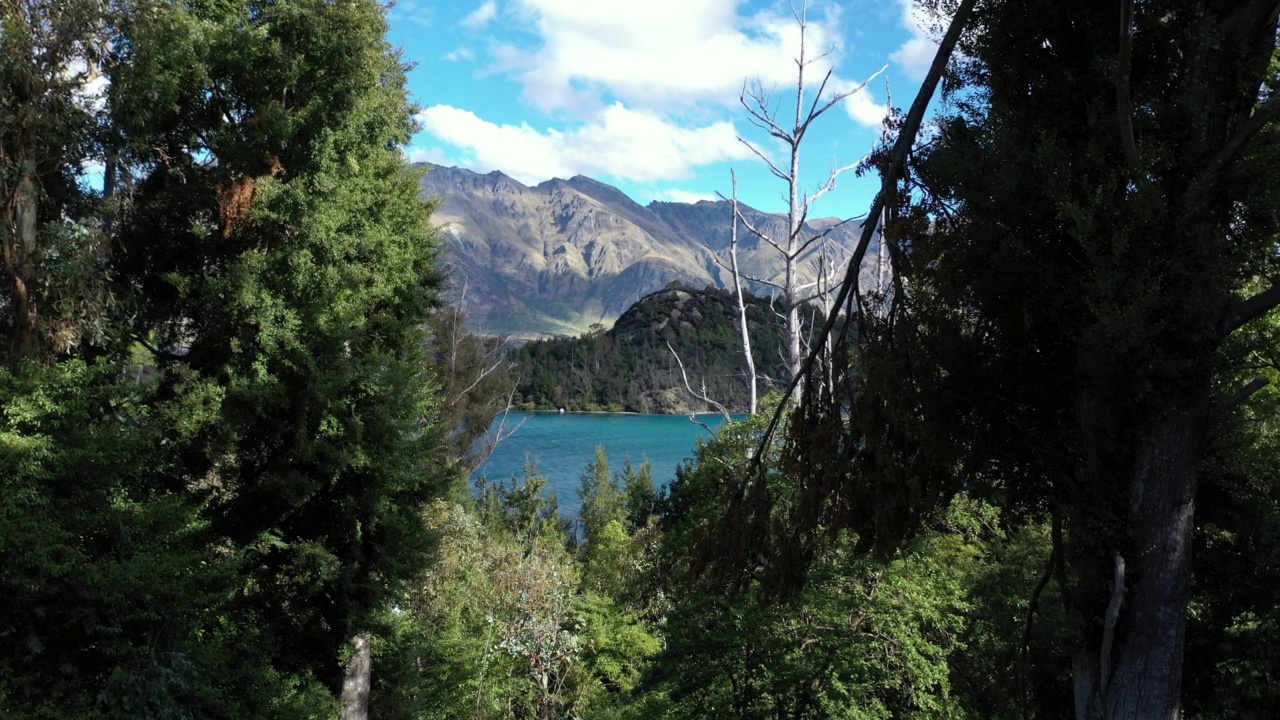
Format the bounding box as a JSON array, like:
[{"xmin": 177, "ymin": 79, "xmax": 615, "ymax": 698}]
[{"xmin": 0, "ymin": 0, "xmax": 111, "ymax": 361}]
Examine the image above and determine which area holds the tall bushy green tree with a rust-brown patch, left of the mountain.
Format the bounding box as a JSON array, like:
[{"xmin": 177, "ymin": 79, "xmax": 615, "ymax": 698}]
[{"xmin": 111, "ymin": 0, "xmax": 443, "ymax": 707}]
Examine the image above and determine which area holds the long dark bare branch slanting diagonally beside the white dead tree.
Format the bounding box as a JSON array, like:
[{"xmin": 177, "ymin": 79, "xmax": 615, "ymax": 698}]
[{"xmin": 735, "ymin": 0, "xmax": 977, "ymax": 458}]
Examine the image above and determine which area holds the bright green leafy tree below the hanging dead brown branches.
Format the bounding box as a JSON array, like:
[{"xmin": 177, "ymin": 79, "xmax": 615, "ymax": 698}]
[{"xmin": 645, "ymin": 393, "xmax": 983, "ymax": 719}]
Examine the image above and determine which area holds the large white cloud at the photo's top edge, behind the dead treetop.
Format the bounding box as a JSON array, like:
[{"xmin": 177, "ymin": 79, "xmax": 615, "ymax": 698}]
[{"xmin": 497, "ymin": 0, "xmax": 860, "ymax": 111}]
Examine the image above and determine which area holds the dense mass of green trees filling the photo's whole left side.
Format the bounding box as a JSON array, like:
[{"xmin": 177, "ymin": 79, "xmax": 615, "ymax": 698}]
[{"xmin": 0, "ymin": 0, "xmax": 449, "ymax": 719}]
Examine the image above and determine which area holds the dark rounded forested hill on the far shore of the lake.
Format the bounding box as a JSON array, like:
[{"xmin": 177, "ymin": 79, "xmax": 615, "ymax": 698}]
[{"xmin": 509, "ymin": 286, "xmax": 786, "ymax": 413}]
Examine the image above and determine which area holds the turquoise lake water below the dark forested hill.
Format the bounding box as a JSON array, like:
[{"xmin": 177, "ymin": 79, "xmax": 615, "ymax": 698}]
[{"xmin": 476, "ymin": 413, "xmax": 724, "ymax": 518}]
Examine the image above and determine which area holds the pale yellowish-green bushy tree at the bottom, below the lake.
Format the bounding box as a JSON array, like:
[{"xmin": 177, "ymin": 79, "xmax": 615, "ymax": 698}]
[{"xmin": 374, "ymin": 461, "xmax": 593, "ymax": 720}]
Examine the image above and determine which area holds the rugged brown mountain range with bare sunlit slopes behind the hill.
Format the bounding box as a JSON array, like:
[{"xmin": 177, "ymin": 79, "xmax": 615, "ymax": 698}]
[{"xmin": 422, "ymin": 167, "xmax": 878, "ymax": 340}]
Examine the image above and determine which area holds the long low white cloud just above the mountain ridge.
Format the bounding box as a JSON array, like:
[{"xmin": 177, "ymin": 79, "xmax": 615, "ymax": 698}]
[{"xmin": 419, "ymin": 102, "xmax": 750, "ymax": 183}]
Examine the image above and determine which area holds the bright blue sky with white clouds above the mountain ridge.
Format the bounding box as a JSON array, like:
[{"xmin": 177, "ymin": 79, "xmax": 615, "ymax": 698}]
[{"xmin": 388, "ymin": 0, "xmax": 936, "ymax": 218}]
